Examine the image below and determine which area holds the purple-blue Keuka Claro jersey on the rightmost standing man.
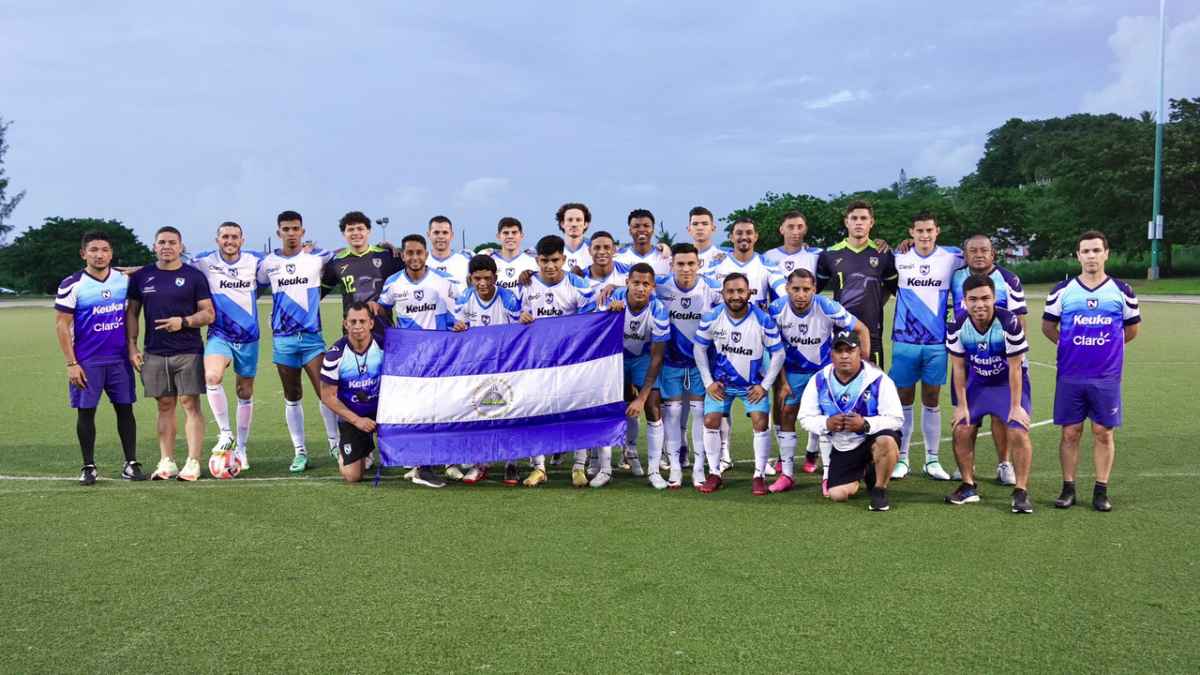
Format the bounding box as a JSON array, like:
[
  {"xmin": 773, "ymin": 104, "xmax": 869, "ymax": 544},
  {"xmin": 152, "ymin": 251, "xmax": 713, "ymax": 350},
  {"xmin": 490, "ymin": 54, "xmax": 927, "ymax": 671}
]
[{"xmin": 1042, "ymin": 276, "xmax": 1141, "ymax": 381}]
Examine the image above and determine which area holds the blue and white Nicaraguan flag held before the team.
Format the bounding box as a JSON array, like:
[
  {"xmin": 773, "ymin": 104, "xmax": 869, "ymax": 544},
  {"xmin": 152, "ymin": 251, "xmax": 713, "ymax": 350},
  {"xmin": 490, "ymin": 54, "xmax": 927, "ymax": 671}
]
[{"xmin": 376, "ymin": 312, "xmax": 625, "ymax": 466}]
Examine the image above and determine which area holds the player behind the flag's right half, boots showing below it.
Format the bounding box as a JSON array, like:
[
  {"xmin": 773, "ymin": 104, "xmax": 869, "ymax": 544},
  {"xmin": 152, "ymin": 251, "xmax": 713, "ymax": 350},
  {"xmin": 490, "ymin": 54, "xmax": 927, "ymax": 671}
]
[{"xmin": 520, "ymin": 234, "xmax": 597, "ymax": 488}]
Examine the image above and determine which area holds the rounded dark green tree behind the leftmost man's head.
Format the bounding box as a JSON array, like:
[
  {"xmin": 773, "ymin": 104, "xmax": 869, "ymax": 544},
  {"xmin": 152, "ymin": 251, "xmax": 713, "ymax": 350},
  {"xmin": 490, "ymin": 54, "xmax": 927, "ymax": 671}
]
[{"xmin": 0, "ymin": 217, "xmax": 154, "ymax": 293}]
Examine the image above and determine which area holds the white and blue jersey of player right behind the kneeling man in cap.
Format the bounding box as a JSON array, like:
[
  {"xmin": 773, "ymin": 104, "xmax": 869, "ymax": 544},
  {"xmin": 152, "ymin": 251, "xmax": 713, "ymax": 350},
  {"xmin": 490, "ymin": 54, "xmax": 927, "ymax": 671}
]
[{"xmin": 770, "ymin": 295, "xmax": 858, "ymax": 375}]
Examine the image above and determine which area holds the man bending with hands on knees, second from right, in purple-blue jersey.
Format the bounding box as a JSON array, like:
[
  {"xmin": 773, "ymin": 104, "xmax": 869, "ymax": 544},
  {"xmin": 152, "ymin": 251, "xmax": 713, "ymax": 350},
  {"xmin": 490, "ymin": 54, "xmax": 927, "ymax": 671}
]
[{"xmin": 950, "ymin": 273, "xmax": 1033, "ymax": 513}]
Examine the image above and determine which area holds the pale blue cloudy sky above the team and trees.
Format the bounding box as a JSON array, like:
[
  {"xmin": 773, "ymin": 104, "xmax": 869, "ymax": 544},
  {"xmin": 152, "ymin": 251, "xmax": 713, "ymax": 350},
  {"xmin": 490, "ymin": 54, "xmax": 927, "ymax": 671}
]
[{"xmin": 0, "ymin": 0, "xmax": 1200, "ymax": 247}]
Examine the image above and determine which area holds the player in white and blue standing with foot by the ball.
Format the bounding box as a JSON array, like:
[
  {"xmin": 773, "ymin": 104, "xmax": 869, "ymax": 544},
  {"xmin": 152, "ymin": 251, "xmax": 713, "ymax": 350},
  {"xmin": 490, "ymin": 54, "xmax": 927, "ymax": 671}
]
[{"xmin": 188, "ymin": 221, "xmax": 262, "ymax": 471}]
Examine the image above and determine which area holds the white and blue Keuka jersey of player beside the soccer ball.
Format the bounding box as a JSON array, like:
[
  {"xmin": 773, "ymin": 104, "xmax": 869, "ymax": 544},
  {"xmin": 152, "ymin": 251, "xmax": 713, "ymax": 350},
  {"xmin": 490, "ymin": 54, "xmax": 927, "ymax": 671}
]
[{"xmin": 188, "ymin": 250, "xmax": 263, "ymax": 344}]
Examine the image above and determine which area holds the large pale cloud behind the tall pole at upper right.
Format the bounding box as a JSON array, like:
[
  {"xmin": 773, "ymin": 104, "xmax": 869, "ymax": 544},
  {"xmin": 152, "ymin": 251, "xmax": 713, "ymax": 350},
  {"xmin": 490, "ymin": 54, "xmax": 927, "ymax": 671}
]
[{"xmin": 1080, "ymin": 16, "xmax": 1200, "ymax": 115}]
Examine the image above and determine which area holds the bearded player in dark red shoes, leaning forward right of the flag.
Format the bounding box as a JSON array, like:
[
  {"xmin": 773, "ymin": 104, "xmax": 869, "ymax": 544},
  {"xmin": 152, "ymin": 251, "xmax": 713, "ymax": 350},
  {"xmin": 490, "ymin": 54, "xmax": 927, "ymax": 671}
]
[{"xmin": 692, "ymin": 271, "xmax": 785, "ymax": 495}]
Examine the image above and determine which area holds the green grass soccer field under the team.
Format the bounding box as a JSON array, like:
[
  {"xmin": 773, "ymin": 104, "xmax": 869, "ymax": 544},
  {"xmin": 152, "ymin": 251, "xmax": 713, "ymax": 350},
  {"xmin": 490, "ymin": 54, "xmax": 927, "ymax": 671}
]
[{"xmin": 0, "ymin": 296, "xmax": 1200, "ymax": 673}]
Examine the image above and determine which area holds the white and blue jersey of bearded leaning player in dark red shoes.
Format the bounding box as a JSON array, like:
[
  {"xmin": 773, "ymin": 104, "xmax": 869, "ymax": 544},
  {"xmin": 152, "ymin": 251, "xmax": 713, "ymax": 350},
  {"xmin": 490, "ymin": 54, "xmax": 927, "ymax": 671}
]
[{"xmin": 696, "ymin": 305, "xmax": 784, "ymax": 390}]
